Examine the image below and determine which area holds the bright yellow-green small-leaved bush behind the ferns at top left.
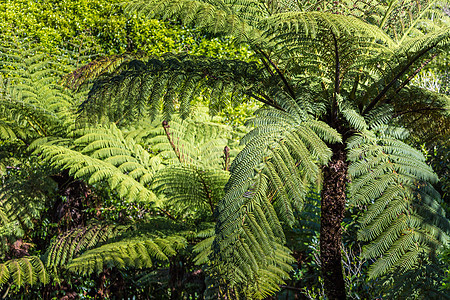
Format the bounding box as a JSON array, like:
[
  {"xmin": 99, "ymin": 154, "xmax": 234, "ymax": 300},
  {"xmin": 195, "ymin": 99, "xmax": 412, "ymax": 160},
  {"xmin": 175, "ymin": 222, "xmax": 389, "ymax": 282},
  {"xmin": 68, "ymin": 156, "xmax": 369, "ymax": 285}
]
[{"xmin": 0, "ymin": 0, "xmax": 247, "ymax": 58}]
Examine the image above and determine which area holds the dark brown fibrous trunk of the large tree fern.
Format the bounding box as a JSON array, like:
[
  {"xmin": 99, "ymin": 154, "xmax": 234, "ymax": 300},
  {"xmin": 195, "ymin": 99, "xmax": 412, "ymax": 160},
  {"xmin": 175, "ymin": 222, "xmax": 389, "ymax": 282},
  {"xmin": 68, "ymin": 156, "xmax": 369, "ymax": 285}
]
[{"xmin": 320, "ymin": 144, "xmax": 348, "ymax": 300}]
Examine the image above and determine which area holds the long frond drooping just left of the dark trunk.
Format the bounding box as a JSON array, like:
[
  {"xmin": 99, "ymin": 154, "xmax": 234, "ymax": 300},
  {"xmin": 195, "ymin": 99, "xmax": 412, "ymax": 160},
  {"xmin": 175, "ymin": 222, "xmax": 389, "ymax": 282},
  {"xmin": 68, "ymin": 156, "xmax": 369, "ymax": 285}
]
[{"xmin": 214, "ymin": 93, "xmax": 340, "ymax": 298}]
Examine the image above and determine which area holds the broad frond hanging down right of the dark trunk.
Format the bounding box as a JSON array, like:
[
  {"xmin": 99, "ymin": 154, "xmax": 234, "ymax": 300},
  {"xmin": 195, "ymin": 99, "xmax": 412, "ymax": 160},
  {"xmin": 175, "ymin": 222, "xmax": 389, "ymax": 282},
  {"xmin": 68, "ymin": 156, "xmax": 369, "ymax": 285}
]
[{"xmin": 348, "ymin": 128, "xmax": 450, "ymax": 277}]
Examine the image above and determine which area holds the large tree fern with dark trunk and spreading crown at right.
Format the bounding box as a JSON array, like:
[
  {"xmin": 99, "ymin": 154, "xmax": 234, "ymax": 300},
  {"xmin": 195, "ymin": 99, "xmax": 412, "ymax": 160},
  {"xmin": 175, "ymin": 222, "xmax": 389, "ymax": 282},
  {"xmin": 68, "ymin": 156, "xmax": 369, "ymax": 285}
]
[{"xmin": 59, "ymin": 0, "xmax": 450, "ymax": 299}]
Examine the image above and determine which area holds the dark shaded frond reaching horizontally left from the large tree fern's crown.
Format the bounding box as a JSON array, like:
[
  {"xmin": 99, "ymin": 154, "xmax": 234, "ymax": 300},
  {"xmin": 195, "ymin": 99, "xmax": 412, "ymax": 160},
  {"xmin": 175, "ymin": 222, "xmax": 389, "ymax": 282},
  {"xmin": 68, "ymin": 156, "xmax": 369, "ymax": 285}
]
[{"xmin": 70, "ymin": 54, "xmax": 264, "ymax": 121}]
